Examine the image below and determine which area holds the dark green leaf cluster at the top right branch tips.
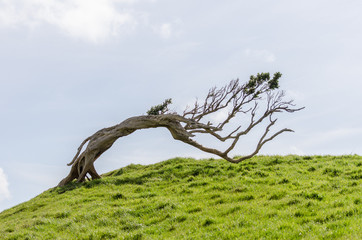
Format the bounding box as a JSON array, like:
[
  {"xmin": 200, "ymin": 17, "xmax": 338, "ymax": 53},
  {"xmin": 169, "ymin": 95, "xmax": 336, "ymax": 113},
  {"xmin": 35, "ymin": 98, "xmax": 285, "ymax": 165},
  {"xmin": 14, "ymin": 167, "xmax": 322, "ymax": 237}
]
[{"xmin": 244, "ymin": 72, "xmax": 282, "ymax": 95}]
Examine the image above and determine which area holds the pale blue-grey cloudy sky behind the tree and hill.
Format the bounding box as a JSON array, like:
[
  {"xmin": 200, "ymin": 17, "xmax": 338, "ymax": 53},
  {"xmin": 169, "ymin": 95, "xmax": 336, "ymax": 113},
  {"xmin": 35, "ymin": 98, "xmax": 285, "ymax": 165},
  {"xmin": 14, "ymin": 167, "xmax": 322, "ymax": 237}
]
[{"xmin": 0, "ymin": 0, "xmax": 362, "ymax": 211}]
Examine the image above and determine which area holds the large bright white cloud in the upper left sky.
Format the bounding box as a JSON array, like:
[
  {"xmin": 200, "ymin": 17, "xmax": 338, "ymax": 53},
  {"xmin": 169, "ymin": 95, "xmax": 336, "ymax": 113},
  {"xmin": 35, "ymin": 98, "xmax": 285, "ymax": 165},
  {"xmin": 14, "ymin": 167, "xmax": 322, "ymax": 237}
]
[{"xmin": 0, "ymin": 0, "xmax": 137, "ymax": 43}]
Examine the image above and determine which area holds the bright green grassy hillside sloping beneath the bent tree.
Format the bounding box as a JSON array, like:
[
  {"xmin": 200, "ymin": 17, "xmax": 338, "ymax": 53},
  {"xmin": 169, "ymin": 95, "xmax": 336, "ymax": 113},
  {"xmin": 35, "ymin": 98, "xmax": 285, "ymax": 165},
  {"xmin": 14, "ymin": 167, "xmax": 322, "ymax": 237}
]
[{"xmin": 0, "ymin": 156, "xmax": 362, "ymax": 239}]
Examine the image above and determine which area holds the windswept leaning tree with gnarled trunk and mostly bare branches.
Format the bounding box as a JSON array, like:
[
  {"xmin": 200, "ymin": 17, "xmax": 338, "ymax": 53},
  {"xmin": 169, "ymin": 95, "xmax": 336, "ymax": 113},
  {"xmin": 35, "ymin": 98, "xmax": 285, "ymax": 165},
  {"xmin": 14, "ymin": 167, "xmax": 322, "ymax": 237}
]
[{"xmin": 58, "ymin": 72, "xmax": 303, "ymax": 186}]
